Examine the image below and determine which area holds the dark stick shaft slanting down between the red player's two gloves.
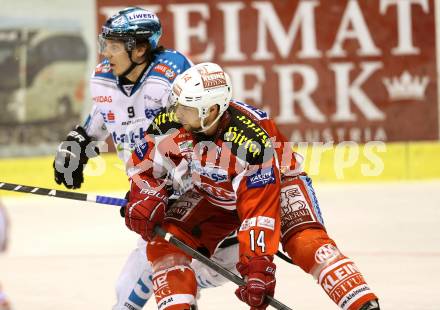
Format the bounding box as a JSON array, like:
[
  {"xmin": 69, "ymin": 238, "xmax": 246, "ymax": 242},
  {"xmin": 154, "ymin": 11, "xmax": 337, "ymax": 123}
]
[{"xmin": 154, "ymin": 226, "xmax": 292, "ymax": 310}]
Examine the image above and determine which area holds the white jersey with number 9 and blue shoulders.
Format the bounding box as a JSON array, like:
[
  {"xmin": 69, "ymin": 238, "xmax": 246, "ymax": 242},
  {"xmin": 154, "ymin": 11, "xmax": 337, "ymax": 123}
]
[{"xmin": 83, "ymin": 50, "xmax": 192, "ymax": 167}]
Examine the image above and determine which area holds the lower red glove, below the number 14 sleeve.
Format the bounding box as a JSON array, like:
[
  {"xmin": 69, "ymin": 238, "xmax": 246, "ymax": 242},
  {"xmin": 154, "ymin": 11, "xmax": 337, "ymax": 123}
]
[{"xmin": 235, "ymin": 256, "xmax": 276, "ymax": 310}]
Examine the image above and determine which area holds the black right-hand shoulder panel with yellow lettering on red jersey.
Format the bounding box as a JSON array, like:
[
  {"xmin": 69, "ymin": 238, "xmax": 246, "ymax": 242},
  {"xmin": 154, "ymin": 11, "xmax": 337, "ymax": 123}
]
[{"xmin": 223, "ymin": 106, "xmax": 273, "ymax": 165}]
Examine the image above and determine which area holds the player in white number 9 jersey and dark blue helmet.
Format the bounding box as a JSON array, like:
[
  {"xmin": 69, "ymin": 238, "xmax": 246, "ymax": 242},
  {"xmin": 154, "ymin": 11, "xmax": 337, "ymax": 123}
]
[{"xmin": 54, "ymin": 8, "xmax": 238, "ymax": 310}]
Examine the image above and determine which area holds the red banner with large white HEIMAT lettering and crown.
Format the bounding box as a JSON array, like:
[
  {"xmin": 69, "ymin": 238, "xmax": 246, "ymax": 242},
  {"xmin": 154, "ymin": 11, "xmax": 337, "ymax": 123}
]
[{"xmin": 96, "ymin": 0, "xmax": 439, "ymax": 142}]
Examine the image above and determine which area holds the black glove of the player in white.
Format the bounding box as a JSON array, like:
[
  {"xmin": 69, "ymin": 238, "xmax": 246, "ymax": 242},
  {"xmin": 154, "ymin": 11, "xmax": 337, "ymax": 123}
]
[{"xmin": 53, "ymin": 126, "xmax": 99, "ymax": 189}]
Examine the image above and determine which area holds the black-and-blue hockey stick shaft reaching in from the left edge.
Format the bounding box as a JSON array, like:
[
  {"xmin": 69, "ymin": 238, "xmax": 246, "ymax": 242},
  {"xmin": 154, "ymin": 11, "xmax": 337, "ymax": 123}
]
[{"xmin": 0, "ymin": 182, "xmax": 127, "ymax": 207}]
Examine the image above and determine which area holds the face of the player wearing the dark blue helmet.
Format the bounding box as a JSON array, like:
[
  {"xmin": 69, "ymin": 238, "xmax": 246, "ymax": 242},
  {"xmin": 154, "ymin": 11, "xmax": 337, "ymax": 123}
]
[{"xmin": 100, "ymin": 40, "xmax": 131, "ymax": 76}]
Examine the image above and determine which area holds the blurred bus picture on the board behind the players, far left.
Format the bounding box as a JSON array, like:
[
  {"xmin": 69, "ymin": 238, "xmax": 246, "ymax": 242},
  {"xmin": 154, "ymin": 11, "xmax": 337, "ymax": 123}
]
[{"xmin": 0, "ymin": 23, "xmax": 87, "ymax": 149}]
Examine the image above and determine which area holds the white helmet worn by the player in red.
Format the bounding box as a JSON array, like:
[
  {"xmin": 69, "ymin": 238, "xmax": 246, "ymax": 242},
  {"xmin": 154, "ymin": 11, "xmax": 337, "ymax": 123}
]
[{"xmin": 169, "ymin": 62, "xmax": 232, "ymax": 132}]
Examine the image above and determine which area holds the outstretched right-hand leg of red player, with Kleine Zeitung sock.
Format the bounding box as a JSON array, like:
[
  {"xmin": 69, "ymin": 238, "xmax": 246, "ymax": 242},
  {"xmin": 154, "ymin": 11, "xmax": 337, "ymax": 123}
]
[{"xmin": 281, "ymin": 175, "xmax": 377, "ymax": 310}]
